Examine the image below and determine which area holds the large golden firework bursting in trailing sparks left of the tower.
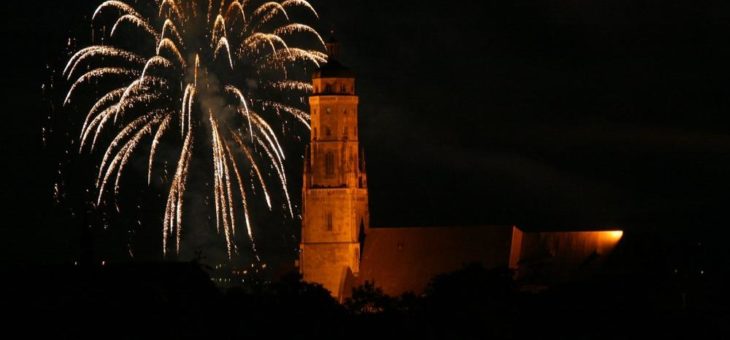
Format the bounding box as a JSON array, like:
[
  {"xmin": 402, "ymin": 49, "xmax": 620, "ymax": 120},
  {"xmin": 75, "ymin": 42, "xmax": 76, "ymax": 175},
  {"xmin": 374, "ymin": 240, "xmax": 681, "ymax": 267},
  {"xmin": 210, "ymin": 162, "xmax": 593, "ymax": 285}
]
[{"xmin": 63, "ymin": 0, "xmax": 326, "ymax": 257}]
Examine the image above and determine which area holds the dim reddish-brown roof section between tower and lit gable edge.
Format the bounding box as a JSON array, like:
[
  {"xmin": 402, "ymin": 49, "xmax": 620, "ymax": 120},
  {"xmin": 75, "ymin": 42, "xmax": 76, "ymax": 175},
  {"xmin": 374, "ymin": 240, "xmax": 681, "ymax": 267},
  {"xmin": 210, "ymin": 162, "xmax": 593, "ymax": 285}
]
[{"xmin": 357, "ymin": 226, "xmax": 513, "ymax": 296}]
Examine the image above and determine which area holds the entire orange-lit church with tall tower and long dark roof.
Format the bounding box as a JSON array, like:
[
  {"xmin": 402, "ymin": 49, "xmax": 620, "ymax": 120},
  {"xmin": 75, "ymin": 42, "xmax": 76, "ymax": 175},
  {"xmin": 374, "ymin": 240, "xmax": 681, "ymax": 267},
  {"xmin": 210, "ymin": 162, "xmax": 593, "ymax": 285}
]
[{"xmin": 298, "ymin": 39, "xmax": 623, "ymax": 301}]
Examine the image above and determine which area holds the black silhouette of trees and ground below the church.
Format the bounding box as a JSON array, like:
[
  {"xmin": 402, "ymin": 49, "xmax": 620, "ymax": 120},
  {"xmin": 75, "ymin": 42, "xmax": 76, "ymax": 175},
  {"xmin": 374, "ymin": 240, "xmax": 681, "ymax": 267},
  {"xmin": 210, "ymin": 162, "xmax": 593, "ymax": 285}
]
[{"xmin": 2, "ymin": 230, "xmax": 730, "ymax": 339}]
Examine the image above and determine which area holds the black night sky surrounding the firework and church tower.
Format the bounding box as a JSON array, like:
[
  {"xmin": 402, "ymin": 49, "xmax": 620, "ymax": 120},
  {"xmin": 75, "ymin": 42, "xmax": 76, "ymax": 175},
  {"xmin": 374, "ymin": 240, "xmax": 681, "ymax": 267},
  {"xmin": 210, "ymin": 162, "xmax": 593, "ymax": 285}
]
[{"xmin": 0, "ymin": 0, "xmax": 730, "ymax": 262}]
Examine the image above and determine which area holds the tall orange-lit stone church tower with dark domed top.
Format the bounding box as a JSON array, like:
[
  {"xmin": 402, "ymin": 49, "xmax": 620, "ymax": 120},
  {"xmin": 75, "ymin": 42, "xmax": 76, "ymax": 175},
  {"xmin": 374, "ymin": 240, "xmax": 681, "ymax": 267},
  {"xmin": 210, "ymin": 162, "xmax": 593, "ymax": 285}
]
[{"xmin": 299, "ymin": 39, "xmax": 370, "ymax": 299}]
